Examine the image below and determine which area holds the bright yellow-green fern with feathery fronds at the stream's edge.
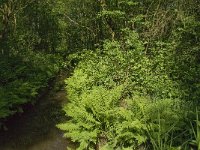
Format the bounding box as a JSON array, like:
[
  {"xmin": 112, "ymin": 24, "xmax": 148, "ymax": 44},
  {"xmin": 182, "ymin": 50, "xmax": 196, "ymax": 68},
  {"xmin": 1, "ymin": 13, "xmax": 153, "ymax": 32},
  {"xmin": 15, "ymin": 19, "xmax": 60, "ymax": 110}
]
[{"xmin": 58, "ymin": 85, "xmax": 147, "ymax": 150}]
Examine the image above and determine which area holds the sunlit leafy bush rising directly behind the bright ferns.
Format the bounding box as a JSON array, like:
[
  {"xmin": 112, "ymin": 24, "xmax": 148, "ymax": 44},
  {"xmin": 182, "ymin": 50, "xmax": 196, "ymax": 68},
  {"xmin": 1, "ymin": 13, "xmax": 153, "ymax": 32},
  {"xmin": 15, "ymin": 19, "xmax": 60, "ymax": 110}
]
[{"xmin": 66, "ymin": 30, "xmax": 179, "ymax": 99}]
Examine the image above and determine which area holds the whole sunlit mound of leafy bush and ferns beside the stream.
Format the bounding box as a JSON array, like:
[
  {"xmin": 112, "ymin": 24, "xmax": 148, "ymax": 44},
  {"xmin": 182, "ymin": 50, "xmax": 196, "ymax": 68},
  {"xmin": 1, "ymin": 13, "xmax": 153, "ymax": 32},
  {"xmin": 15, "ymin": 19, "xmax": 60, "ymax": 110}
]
[{"xmin": 58, "ymin": 30, "xmax": 190, "ymax": 150}]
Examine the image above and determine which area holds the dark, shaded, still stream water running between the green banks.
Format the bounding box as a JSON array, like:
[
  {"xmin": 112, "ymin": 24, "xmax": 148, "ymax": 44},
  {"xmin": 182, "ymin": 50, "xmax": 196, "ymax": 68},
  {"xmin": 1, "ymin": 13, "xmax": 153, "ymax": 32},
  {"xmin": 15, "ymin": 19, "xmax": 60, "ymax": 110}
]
[{"xmin": 0, "ymin": 74, "xmax": 74, "ymax": 150}]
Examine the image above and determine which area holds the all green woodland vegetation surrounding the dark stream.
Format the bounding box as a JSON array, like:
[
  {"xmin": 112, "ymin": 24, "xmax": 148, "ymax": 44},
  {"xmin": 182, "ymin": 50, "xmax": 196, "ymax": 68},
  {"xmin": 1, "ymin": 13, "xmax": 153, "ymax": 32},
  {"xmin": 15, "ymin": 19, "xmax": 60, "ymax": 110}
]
[{"xmin": 0, "ymin": 0, "xmax": 200, "ymax": 150}]
